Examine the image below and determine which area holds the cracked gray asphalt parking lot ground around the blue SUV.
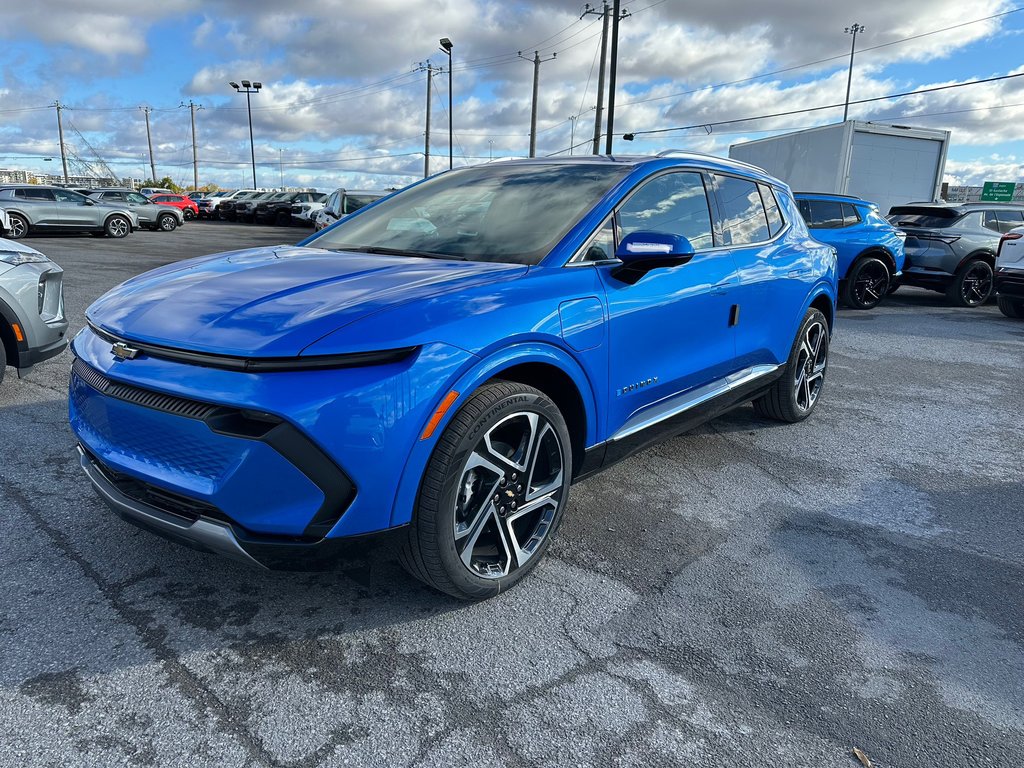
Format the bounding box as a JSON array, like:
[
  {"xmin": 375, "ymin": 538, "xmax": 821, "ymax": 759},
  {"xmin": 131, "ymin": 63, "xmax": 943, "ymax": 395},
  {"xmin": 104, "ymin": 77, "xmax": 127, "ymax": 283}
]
[{"xmin": 0, "ymin": 222, "xmax": 1024, "ymax": 768}]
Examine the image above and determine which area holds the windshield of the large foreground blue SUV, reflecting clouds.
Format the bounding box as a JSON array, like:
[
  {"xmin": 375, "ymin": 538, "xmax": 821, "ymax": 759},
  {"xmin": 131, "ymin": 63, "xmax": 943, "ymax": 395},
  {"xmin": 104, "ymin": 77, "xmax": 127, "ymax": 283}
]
[{"xmin": 310, "ymin": 164, "xmax": 630, "ymax": 264}]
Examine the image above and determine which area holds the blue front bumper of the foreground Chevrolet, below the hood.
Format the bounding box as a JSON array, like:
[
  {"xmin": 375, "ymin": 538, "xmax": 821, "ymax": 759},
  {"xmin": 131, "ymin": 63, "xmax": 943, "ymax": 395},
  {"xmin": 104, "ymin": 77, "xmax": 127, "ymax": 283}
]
[{"xmin": 69, "ymin": 328, "xmax": 469, "ymax": 567}]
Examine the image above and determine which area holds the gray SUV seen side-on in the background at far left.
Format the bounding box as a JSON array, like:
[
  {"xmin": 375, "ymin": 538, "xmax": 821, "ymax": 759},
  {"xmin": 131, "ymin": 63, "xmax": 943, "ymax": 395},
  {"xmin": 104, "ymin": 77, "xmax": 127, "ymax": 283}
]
[{"xmin": 0, "ymin": 184, "xmax": 138, "ymax": 240}]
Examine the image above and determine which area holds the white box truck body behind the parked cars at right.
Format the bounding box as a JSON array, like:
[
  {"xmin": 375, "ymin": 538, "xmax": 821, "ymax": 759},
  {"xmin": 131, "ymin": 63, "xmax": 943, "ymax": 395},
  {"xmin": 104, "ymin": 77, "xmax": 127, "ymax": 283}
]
[{"xmin": 729, "ymin": 120, "xmax": 949, "ymax": 215}]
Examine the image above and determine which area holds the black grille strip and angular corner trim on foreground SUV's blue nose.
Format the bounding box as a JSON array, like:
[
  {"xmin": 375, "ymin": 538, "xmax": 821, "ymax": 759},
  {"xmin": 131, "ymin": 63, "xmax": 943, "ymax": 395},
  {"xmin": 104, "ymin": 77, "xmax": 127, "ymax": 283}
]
[{"xmin": 72, "ymin": 358, "xmax": 356, "ymax": 542}]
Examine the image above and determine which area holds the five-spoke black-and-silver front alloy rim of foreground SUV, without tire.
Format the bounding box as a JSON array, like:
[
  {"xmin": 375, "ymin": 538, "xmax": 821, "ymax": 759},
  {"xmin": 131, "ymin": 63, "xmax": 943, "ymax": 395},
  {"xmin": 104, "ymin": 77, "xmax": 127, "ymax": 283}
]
[{"xmin": 453, "ymin": 412, "xmax": 565, "ymax": 579}]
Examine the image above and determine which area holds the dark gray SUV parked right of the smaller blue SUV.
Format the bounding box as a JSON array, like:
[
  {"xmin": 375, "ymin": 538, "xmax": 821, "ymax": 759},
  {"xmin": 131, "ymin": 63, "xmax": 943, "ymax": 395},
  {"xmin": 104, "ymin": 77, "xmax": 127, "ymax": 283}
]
[{"xmin": 889, "ymin": 203, "xmax": 1024, "ymax": 306}]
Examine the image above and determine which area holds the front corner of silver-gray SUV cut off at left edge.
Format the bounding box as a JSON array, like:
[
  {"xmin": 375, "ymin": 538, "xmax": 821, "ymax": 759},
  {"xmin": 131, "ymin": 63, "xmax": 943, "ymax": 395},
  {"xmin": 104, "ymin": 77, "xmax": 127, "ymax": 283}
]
[{"xmin": 0, "ymin": 240, "xmax": 68, "ymax": 381}]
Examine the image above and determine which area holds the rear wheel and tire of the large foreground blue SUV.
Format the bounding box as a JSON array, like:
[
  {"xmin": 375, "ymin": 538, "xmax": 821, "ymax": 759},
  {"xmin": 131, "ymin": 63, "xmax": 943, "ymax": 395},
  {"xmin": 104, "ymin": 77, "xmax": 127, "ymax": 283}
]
[{"xmin": 754, "ymin": 307, "xmax": 829, "ymax": 424}]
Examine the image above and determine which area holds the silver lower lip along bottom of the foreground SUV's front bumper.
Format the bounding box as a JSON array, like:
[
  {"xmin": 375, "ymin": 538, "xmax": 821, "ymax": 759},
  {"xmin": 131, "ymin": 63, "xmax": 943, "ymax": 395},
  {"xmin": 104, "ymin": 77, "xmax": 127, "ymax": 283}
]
[{"xmin": 77, "ymin": 446, "xmax": 266, "ymax": 568}]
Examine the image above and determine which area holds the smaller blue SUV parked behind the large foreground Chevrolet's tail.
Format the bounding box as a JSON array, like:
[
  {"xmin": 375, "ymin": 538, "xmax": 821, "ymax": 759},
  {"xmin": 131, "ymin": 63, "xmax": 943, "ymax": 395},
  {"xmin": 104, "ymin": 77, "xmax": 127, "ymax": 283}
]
[{"xmin": 794, "ymin": 193, "xmax": 906, "ymax": 309}]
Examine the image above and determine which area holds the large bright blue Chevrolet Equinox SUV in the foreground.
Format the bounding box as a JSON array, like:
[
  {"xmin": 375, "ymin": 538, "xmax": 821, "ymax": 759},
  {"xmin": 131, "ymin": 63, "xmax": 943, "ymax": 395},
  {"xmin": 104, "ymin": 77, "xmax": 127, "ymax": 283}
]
[{"xmin": 70, "ymin": 155, "xmax": 837, "ymax": 599}]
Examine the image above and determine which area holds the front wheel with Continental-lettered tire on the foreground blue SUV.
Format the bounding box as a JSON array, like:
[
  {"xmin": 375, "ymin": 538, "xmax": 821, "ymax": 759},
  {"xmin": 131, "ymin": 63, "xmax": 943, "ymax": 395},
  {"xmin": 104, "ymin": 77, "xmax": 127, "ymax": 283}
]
[{"xmin": 399, "ymin": 381, "xmax": 572, "ymax": 600}]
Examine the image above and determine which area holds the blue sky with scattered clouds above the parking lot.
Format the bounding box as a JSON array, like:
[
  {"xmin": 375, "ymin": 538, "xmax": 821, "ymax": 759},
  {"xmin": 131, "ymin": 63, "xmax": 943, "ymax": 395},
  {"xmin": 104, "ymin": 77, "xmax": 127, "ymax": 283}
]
[{"xmin": 0, "ymin": 0, "xmax": 1024, "ymax": 190}]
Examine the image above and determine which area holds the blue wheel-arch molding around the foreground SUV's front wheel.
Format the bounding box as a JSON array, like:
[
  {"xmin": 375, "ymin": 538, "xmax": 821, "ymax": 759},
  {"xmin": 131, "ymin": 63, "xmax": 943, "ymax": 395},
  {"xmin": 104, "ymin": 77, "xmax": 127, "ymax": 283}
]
[{"xmin": 391, "ymin": 341, "xmax": 598, "ymax": 526}]
